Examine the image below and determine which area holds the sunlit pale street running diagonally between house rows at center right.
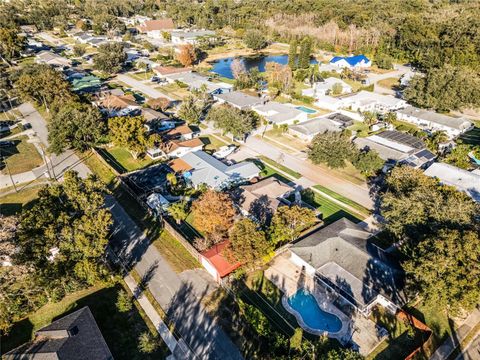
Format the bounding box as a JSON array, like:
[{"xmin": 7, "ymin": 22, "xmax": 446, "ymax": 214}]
[{"xmin": 242, "ymin": 136, "xmax": 373, "ymax": 209}]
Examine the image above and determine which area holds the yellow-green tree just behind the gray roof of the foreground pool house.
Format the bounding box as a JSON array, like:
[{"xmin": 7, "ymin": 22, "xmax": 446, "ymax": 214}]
[{"xmin": 270, "ymin": 205, "xmax": 318, "ymax": 245}]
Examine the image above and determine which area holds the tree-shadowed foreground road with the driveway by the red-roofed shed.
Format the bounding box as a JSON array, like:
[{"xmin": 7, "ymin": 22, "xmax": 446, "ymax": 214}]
[{"xmin": 107, "ymin": 197, "xmax": 242, "ymax": 360}]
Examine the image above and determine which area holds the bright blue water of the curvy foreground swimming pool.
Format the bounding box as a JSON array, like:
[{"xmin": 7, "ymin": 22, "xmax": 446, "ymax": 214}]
[{"xmin": 287, "ymin": 289, "xmax": 342, "ymax": 332}]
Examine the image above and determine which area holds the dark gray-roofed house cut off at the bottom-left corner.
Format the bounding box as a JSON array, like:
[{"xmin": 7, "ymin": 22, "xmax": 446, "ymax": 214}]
[{"xmin": 3, "ymin": 306, "xmax": 113, "ymax": 360}]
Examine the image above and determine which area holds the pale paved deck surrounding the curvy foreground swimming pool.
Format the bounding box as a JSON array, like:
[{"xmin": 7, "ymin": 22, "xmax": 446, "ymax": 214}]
[{"xmin": 265, "ymin": 250, "xmax": 383, "ymax": 356}]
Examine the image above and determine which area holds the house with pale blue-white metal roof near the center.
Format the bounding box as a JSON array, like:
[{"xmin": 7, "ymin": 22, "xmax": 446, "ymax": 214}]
[{"xmin": 171, "ymin": 151, "xmax": 260, "ymax": 190}]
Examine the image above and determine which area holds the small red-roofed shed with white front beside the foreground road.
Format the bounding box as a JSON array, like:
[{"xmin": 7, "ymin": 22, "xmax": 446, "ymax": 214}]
[{"xmin": 200, "ymin": 240, "xmax": 241, "ymax": 281}]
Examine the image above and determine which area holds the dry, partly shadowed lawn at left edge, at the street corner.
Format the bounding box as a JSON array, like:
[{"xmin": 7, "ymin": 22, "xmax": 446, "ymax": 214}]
[{"xmin": 0, "ymin": 136, "xmax": 43, "ymax": 174}]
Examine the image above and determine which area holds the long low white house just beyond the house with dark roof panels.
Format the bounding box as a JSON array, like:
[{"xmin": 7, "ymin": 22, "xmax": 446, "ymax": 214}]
[{"xmin": 397, "ymin": 106, "xmax": 473, "ymax": 139}]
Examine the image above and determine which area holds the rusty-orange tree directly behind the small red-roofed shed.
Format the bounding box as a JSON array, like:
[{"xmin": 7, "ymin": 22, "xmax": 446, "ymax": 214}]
[{"xmin": 192, "ymin": 190, "xmax": 236, "ymax": 243}]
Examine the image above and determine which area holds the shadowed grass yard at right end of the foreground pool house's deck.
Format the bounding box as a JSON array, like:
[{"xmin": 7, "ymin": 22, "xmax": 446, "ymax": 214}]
[{"xmin": 367, "ymin": 307, "xmax": 428, "ymax": 360}]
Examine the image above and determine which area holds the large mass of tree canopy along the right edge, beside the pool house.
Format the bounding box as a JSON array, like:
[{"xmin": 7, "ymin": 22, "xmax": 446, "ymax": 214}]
[{"xmin": 381, "ymin": 167, "xmax": 480, "ymax": 313}]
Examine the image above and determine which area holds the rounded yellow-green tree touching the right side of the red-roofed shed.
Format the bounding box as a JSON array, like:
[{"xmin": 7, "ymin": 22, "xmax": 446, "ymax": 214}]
[{"xmin": 229, "ymin": 218, "xmax": 271, "ymax": 264}]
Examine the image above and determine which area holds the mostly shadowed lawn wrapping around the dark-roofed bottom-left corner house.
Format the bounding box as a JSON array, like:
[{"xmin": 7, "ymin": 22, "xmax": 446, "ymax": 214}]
[{"xmin": 2, "ymin": 285, "xmax": 168, "ymax": 360}]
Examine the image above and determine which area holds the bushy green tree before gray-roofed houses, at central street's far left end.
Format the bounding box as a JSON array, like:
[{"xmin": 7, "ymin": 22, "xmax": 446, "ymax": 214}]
[{"xmin": 206, "ymin": 105, "xmax": 258, "ymax": 139}]
